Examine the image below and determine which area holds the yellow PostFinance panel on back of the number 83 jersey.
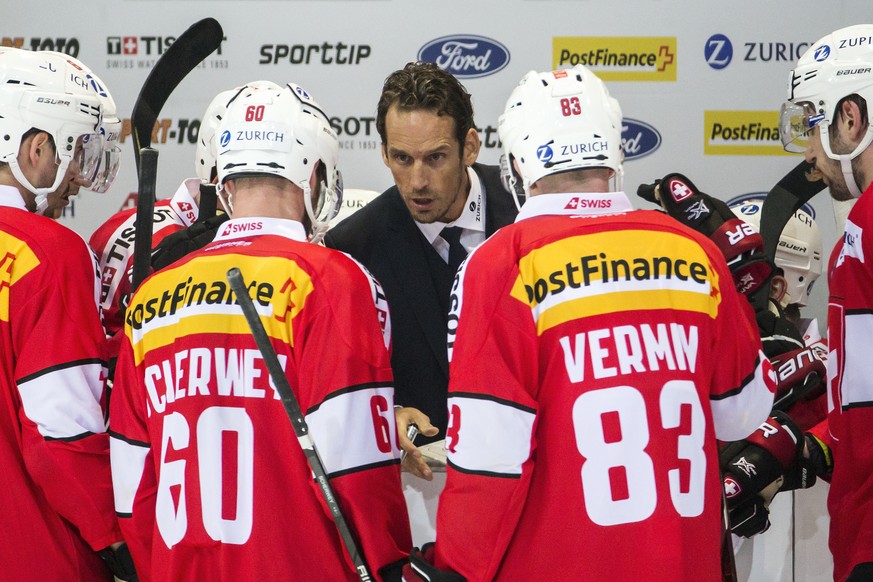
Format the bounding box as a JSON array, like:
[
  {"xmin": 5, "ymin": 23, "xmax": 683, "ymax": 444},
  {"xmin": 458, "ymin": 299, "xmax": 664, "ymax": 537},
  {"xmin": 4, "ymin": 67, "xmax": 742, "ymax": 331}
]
[{"xmin": 511, "ymin": 230, "xmax": 721, "ymax": 334}]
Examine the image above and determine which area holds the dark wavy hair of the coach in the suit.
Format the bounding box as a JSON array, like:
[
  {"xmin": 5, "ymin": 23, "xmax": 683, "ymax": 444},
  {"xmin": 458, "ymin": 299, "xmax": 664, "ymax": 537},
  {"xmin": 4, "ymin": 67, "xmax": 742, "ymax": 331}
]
[{"xmin": 376, "ymin": 61, "xmax": 476, "ymax": 152}]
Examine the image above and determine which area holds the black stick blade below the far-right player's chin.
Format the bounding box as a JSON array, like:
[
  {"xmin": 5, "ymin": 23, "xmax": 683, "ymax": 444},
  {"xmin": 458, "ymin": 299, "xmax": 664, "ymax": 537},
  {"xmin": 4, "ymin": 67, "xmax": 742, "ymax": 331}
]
[{"xmin": 761, "ymin": 161, "xmax": 825, "ymax": 261}]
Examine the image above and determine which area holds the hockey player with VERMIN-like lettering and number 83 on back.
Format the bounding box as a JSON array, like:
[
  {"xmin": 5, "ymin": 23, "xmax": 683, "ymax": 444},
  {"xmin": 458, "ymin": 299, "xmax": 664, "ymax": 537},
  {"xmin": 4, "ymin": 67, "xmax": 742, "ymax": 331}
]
[{"xmin": 416, "ymin": 65, "xmax": 775, "ymax": 582}]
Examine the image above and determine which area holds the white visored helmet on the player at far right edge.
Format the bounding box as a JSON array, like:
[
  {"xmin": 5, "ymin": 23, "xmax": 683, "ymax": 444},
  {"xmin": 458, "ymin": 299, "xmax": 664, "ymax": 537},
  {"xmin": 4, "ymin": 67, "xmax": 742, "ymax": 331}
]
[{"xmin": 779, "ymin": 24, "xmax": 873, "ymax": 198}]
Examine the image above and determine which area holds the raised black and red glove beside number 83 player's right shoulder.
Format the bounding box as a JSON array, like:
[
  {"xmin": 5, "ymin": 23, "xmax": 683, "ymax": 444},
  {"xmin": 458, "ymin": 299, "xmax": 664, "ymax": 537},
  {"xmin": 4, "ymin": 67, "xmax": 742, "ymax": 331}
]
[{"xmin": 637, "ymin": 174, "xmax": 773, "ymax": 304}]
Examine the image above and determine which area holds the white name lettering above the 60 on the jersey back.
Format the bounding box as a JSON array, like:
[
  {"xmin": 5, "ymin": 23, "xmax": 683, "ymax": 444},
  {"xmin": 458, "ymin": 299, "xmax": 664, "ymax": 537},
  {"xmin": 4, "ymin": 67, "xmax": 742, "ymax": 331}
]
[{"xmin": 145, "ymin": 348, "xmax": 288, "ymax": 416}]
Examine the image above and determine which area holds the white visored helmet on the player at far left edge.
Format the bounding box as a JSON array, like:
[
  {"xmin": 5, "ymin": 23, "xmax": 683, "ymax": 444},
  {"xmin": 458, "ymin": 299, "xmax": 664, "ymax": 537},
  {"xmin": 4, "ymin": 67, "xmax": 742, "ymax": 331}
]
[{"xmin": 0, "ymin": 48, "xmax": 103, "ymax": 212}]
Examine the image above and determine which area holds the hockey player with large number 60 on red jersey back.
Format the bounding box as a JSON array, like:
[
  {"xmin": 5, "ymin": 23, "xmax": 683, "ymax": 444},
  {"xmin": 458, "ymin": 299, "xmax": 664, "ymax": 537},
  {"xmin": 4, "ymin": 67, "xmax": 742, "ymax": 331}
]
[{"xmin": 111, "ymin": 84, "xmax": 411, "ymax": 581}]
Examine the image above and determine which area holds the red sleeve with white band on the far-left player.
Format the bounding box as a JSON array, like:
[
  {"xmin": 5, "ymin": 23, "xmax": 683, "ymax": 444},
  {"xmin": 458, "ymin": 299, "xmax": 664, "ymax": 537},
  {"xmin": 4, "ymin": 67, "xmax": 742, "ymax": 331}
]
[{"xmin": 9, "ymin": 223, "xmax": 121, "ymax": 550}]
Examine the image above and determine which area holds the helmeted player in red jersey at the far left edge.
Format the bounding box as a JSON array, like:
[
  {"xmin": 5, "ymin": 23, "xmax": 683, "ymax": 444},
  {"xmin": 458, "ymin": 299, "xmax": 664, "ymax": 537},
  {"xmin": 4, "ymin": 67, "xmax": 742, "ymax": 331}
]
[{"xmin": 0, "ymin": 48, "xmax": 130, "ymax": 581}]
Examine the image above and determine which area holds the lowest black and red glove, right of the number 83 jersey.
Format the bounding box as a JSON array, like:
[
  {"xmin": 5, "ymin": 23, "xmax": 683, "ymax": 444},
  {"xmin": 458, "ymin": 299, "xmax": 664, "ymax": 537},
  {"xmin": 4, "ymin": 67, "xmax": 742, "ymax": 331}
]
[{"xmin": 719, "ymin": 411, "xmax": 804, "ymax": 537}]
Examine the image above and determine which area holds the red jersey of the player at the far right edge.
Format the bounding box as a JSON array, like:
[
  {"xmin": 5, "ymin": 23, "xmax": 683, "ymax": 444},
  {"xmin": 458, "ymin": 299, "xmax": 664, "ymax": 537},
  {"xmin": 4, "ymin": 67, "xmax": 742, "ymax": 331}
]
[{"xmin": 813, "ymin": 186, "xmax": 873, "ymax": 580}]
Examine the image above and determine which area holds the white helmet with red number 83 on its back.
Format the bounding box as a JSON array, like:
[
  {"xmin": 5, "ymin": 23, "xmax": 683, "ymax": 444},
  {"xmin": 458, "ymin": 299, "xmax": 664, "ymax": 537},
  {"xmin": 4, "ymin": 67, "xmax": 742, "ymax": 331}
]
[{"xmin": 497, "ymin": 65, "xmax": 623, "ymax": 200}]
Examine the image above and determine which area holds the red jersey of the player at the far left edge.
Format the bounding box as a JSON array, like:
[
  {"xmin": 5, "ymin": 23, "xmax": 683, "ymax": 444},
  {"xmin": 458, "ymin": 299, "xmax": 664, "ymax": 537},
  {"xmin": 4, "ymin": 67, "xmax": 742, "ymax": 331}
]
[{"xmin": 0, "ymin": 186, "xmax": 121, "ymax": 581}]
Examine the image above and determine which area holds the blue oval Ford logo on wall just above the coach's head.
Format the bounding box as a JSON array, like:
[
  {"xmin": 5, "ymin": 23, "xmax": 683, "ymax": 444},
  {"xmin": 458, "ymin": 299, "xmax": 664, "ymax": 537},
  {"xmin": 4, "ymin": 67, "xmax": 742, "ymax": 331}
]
[{"xmin": 418, "ymin": 35, "xmax": 509, "ymax": 79}]
